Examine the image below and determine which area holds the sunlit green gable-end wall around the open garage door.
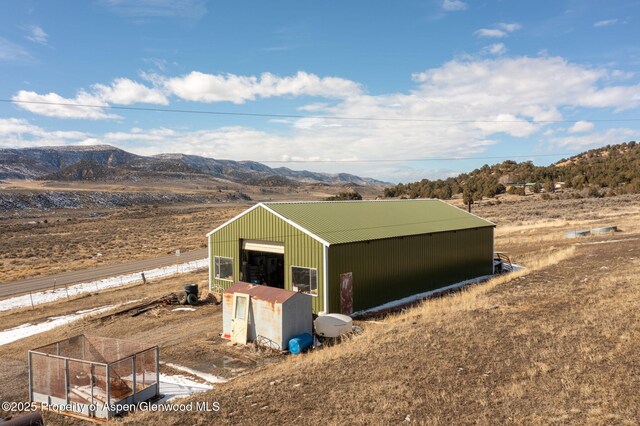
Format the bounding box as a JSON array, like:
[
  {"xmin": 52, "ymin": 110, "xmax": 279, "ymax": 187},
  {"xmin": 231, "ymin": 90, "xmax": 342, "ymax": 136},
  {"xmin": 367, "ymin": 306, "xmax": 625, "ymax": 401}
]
[{"xmin": 209, "ymin": 207, "xmax": 324, "ymax": 313}]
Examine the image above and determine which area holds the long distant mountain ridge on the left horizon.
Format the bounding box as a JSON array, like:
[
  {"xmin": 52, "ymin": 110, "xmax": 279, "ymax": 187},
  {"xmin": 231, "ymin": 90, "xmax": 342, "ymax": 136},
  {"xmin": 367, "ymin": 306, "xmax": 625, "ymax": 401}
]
[{"xmin": 0, "ymin": 145, "xmax": 385, "ymax": 186}]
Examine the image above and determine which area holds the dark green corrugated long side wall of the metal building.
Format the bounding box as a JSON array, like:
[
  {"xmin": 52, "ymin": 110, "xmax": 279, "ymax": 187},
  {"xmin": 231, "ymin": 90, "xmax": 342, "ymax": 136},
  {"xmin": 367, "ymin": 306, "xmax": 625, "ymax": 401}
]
[{"xmin": 329, "ymin": 227, "xmax": 493, "ymax": 312}]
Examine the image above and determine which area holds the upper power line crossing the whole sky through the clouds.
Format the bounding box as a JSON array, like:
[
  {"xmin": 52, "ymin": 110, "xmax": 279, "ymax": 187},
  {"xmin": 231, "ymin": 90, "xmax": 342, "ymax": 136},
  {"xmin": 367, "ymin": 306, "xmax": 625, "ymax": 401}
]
[{"xmin": 0, "ymin": 99, "xmax": 640, "ymax": 124}]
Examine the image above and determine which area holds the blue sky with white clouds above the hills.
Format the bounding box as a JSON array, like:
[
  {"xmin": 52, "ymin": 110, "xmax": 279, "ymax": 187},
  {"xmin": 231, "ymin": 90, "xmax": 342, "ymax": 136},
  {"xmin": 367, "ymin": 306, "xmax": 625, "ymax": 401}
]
[{"xmin": 0, "ymin": 0, "xmax": 640, "ymax": 182}]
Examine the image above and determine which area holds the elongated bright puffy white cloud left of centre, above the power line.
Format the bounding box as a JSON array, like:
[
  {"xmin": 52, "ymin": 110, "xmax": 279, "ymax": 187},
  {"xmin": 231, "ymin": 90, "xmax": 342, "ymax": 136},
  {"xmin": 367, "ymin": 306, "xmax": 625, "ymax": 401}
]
[{"xmin": 160, "ymin": 71, "xmax": 361, "ymax": 104}]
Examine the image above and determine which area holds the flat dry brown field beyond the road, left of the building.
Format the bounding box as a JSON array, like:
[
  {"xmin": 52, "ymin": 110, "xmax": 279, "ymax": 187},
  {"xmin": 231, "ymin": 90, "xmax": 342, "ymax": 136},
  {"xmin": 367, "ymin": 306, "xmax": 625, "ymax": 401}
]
[{"xmin": 0, "ymin": 204, "xmax": 247, "ymax": 283}]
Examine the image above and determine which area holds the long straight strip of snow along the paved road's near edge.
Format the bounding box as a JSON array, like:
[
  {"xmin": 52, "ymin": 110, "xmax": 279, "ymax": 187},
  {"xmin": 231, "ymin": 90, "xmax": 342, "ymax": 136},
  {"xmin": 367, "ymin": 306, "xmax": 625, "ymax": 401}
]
[{"xmin": 0, "ymin": 259, "xmax": 209, "ymax": 312}]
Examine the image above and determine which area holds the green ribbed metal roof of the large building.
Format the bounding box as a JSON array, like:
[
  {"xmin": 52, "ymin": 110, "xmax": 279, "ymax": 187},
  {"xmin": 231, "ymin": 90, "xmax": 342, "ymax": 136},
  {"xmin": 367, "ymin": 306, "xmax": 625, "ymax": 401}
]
[{"xmin": 263, "ymin": 199, "xmax": 495, "ymax": 244}]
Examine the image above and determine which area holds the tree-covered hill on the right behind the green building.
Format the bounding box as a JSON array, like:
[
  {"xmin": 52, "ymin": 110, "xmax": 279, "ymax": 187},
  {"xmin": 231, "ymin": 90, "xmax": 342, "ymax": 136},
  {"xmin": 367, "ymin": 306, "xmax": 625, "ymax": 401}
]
[{"xmin": 384, "ymin": 141, "xmax": 640, "ymax": 200}]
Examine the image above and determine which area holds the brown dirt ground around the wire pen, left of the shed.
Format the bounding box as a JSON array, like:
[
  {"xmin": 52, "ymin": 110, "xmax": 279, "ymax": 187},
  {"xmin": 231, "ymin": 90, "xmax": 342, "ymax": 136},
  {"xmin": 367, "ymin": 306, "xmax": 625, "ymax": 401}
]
[{"xmin": 0, "ymin": 272, "xmax": 281, "ymax": 425}]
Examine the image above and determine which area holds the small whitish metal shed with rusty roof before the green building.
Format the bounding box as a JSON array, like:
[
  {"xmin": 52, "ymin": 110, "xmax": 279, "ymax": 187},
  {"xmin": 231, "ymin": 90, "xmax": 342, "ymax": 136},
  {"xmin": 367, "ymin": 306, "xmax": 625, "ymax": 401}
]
[{"xmin": 222, "ymin": 281, "xmax": 313, "ymax": 350}]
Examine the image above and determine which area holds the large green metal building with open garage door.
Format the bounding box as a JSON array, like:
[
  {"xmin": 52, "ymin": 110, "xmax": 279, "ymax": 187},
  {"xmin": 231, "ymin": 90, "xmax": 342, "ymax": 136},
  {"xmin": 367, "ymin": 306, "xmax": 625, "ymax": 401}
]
[{"xmin": 207, "ymin": 199, "xmax": 495, "ymax": 314}]
